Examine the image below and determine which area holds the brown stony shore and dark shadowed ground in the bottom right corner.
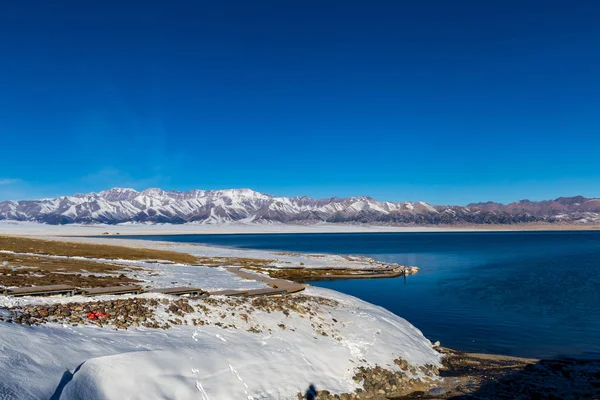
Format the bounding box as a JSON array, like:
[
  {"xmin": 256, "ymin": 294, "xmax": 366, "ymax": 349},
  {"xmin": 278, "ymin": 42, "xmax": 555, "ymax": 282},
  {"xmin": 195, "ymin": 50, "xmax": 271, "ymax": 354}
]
[{"xmin": 308, "ymin": 348, "xmax": 600, "ymax": 400}]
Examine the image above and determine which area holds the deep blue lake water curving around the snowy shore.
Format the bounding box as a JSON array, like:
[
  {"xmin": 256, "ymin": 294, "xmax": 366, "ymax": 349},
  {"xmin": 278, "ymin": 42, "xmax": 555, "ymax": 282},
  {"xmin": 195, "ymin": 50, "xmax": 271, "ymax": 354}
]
[{"xmin": 116, "ymin": 232, "xmax": 600, "ymax": 358}]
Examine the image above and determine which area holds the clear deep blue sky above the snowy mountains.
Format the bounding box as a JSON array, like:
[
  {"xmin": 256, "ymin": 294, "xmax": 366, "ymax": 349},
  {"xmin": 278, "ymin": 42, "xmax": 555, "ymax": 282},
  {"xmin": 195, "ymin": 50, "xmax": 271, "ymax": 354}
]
[{"xmin": 0, "ymin": 0, "xmax": 600, "ymax": 204}]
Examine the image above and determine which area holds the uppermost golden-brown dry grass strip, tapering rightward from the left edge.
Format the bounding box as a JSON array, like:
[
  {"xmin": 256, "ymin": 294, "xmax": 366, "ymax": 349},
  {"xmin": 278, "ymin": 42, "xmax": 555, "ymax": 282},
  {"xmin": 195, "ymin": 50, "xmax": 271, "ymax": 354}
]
[{"xmin": 0, "ymin": 236, "xmax": 198, "ymax": 264}]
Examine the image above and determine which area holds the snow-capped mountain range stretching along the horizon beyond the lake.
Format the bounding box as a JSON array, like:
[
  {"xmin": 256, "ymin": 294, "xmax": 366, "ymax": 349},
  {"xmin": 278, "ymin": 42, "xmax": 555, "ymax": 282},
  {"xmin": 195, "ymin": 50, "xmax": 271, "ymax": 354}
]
[{"xmin": 0, "ymin": 188, "xmax": 600, "ymax": 225}]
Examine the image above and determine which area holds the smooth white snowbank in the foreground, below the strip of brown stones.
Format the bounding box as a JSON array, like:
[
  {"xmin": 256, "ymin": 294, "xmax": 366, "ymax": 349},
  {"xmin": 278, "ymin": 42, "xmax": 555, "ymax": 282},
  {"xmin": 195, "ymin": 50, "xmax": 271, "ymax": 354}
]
[{"xmin": 0, "ymin": 288, "xmax": 440, "ymax": 400}]
